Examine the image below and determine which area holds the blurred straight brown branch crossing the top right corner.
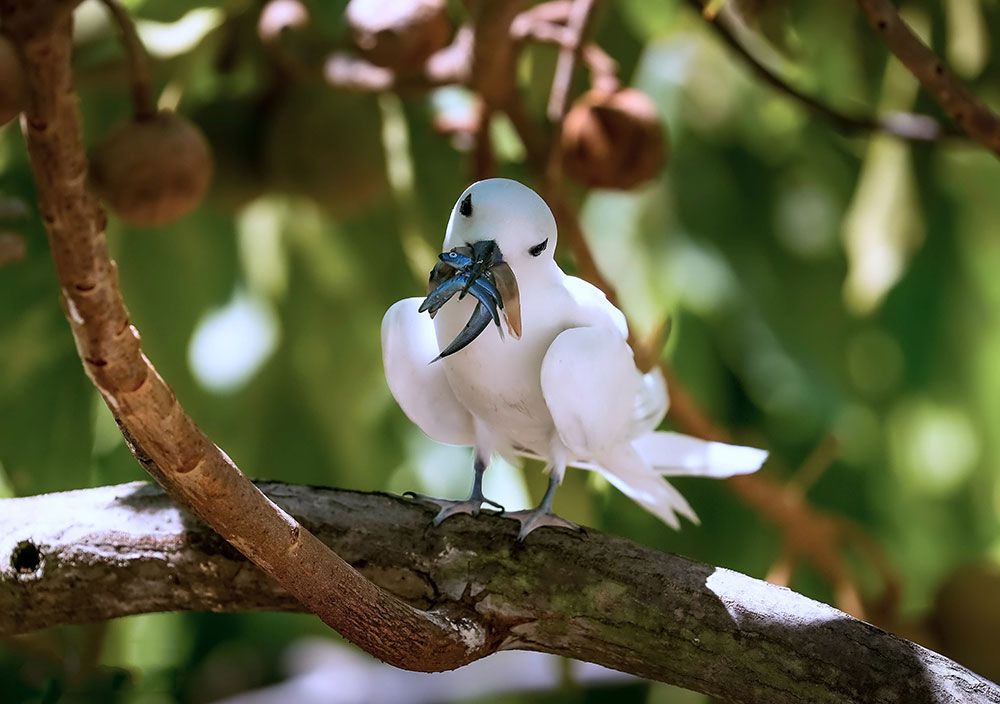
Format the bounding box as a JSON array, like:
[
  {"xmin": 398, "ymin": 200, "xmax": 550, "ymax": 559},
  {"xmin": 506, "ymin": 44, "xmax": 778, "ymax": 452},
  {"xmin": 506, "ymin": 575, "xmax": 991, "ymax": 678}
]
[{"xmin": 858, "ymin": 0, "xmax": 1000, "ymax": 156}]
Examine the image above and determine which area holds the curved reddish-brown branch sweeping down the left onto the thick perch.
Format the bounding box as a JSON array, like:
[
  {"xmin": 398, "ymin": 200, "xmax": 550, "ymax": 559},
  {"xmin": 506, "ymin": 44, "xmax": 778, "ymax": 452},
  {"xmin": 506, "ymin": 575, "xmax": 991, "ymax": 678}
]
[{"xmin": 0, "ymin": 6, "xmax": 496, "ymax": 670}]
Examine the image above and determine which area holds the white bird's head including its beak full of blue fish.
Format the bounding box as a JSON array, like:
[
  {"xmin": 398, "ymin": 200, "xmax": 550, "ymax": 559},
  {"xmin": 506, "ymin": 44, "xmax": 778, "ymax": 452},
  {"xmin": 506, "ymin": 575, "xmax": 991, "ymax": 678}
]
[{"xmin": 421, "ymin": 178, "xmax": 556, "ymax": 357}]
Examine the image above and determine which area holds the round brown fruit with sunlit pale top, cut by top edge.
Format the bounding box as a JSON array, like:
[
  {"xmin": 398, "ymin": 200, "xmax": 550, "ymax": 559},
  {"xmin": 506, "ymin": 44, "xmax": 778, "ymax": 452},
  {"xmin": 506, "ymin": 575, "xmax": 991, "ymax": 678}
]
[{"xmin": 346, "ymin": 0, "xmax": 451, "ymax": 75}]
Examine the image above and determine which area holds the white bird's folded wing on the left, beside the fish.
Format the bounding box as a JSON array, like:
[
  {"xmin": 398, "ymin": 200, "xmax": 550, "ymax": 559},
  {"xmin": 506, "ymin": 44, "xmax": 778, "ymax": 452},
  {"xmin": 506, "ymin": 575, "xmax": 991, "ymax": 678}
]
[{"xmin": 382, "ymin": 298, "xmax": 475, "ymax": 445}]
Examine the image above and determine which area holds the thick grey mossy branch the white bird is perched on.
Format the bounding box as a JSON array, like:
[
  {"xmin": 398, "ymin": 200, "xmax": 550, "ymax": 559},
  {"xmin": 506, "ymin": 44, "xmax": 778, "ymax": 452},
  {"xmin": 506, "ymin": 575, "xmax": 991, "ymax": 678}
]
[{"xmin": 0, "ymin": 482, "xmax": 1000, "ymax": 704}]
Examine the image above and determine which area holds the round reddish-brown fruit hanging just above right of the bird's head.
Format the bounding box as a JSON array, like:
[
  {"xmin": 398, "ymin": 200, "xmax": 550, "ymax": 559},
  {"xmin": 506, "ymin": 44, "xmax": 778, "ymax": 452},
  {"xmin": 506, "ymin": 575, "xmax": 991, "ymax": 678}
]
[{"xmin": 561, "ymin": 88, "xmax": 668, "ymax": 189}]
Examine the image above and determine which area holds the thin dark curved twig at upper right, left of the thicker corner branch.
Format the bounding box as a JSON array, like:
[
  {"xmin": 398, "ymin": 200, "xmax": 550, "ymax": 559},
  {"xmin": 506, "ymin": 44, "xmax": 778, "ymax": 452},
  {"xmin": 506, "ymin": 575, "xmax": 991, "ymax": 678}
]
[{"xmin": 688, "ymin": 0, "xmax": 961, "ymax": 142}]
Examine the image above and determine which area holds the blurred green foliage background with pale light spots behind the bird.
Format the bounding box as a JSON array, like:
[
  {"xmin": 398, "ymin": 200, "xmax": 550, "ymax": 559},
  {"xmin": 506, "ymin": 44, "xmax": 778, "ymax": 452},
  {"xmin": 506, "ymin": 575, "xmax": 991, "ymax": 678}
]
[{"xmin": 0, "ymin": 0, "xmax": 1000, "ymax": 704}]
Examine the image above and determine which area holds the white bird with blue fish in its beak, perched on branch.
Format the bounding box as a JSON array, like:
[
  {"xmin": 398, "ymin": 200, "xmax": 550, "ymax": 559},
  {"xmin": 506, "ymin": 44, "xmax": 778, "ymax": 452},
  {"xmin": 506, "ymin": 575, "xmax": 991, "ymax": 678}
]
[{"xmin": 382, "ymin": 178, "xmax": 767, "ymax": 539}]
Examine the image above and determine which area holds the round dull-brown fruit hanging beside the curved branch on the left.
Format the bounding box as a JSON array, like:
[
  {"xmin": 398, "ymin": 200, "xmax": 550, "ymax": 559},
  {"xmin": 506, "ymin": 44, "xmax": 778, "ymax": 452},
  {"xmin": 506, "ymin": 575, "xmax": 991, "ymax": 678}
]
[{"xmin": 90, "ymin": 111, "xmax": 213, "ymax": 226}]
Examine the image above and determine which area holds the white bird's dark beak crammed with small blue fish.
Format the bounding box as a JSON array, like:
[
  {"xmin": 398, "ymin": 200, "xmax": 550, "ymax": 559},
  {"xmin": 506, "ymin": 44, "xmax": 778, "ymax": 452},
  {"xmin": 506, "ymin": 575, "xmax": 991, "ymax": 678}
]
[{"xmin": 420, "ymin": 240, "xmax": 521, "ymax": 361}]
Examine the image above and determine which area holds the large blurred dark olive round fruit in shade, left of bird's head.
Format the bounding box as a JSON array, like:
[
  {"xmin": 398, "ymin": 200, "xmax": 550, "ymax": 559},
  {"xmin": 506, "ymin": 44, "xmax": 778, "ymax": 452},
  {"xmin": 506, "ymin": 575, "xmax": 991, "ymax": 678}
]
[{"xmin": 264, "ymin": 85, "xmax": 388, "ymax": 217}]
